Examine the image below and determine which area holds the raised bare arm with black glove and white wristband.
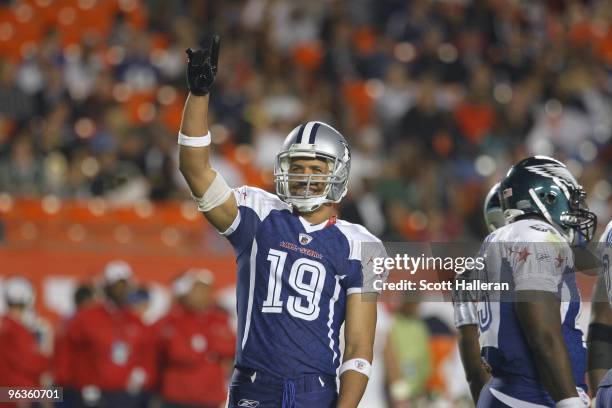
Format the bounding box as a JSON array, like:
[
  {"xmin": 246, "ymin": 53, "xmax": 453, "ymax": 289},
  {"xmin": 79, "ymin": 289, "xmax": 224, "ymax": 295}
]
[{"xmin": 179, "ymin": 36, "xmax": 238, "ymax": 232}]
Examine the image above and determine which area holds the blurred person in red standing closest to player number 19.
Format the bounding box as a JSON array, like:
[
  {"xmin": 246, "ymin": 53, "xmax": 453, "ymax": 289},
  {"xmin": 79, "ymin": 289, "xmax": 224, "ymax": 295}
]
[{"xmin": 158, "ymin": 269, "xmax": 236, "ymax": 408}]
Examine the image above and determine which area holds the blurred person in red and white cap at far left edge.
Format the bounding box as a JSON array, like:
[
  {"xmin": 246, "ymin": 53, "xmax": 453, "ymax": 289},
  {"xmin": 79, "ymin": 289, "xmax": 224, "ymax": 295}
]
[{"xmin": 0, "ymin": 276, "xmax": 49, "ymax": 406}]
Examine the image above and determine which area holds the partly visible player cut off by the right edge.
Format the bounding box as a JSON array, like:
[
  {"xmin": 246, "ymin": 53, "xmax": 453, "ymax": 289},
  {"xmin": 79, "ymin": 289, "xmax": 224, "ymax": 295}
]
[{"xmin": 588, "ymin": 221, "xmax": 612, "ymax": 408}]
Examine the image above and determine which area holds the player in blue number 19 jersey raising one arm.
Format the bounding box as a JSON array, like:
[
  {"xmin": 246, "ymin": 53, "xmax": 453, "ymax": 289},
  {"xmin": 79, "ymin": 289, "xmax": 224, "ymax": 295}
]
[{"xmin": 178, "ymin": 36, "xmax": 385, "ymax": 408}]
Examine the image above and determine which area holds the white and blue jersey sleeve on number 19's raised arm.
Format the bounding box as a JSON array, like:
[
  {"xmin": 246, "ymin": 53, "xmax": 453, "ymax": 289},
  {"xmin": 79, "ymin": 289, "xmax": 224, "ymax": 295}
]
[{"xmin": 221, "ymin": 186, "xmax": 289, "ymax": 250}]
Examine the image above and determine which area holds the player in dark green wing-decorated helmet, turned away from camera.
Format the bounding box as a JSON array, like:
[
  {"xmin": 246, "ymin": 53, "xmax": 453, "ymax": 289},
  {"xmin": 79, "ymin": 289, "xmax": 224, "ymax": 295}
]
[{"xmin": 478, "ymin": 156, "xmax": 597, "ymax": 407}]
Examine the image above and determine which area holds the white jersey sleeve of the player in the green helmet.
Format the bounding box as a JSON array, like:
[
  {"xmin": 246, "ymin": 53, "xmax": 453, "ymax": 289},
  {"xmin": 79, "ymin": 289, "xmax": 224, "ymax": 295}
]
[{"xmin": 505, "ymin": 225, "xmax": 574, "ymax": 293}]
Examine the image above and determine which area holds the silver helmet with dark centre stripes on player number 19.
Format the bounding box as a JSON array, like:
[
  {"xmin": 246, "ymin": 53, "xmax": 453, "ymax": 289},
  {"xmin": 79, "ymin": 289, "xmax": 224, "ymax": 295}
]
[{"xmin": 274, "ymin": 122, "xmax": 351, "ymax": 212}]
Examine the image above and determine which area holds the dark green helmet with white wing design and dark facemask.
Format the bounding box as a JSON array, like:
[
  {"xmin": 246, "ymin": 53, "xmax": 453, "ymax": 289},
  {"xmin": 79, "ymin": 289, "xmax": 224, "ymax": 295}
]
[{"xmin": 499, "ymin": 156, "xmax": 597, "ymax": 244}]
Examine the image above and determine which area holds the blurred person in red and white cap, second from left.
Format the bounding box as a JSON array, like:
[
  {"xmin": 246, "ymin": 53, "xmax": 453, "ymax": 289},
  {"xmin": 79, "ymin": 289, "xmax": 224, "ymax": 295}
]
[{"xmin": 67, "ymin": 261, "xmax": 148, "ymax": 408}]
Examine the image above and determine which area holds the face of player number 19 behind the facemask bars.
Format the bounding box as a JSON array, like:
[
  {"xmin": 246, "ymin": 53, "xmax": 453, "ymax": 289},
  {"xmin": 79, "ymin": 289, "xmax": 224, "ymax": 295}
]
[{"xmin": 289, "ymin": 159, "xmax": 329, "ymax": 197}]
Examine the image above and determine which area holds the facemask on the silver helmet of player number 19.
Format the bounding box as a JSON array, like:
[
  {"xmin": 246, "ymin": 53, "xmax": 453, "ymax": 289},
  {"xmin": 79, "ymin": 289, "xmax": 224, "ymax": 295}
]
[{"xmin": 274, "ymin": 149, "xmax": 349, "ymax": 213}]
